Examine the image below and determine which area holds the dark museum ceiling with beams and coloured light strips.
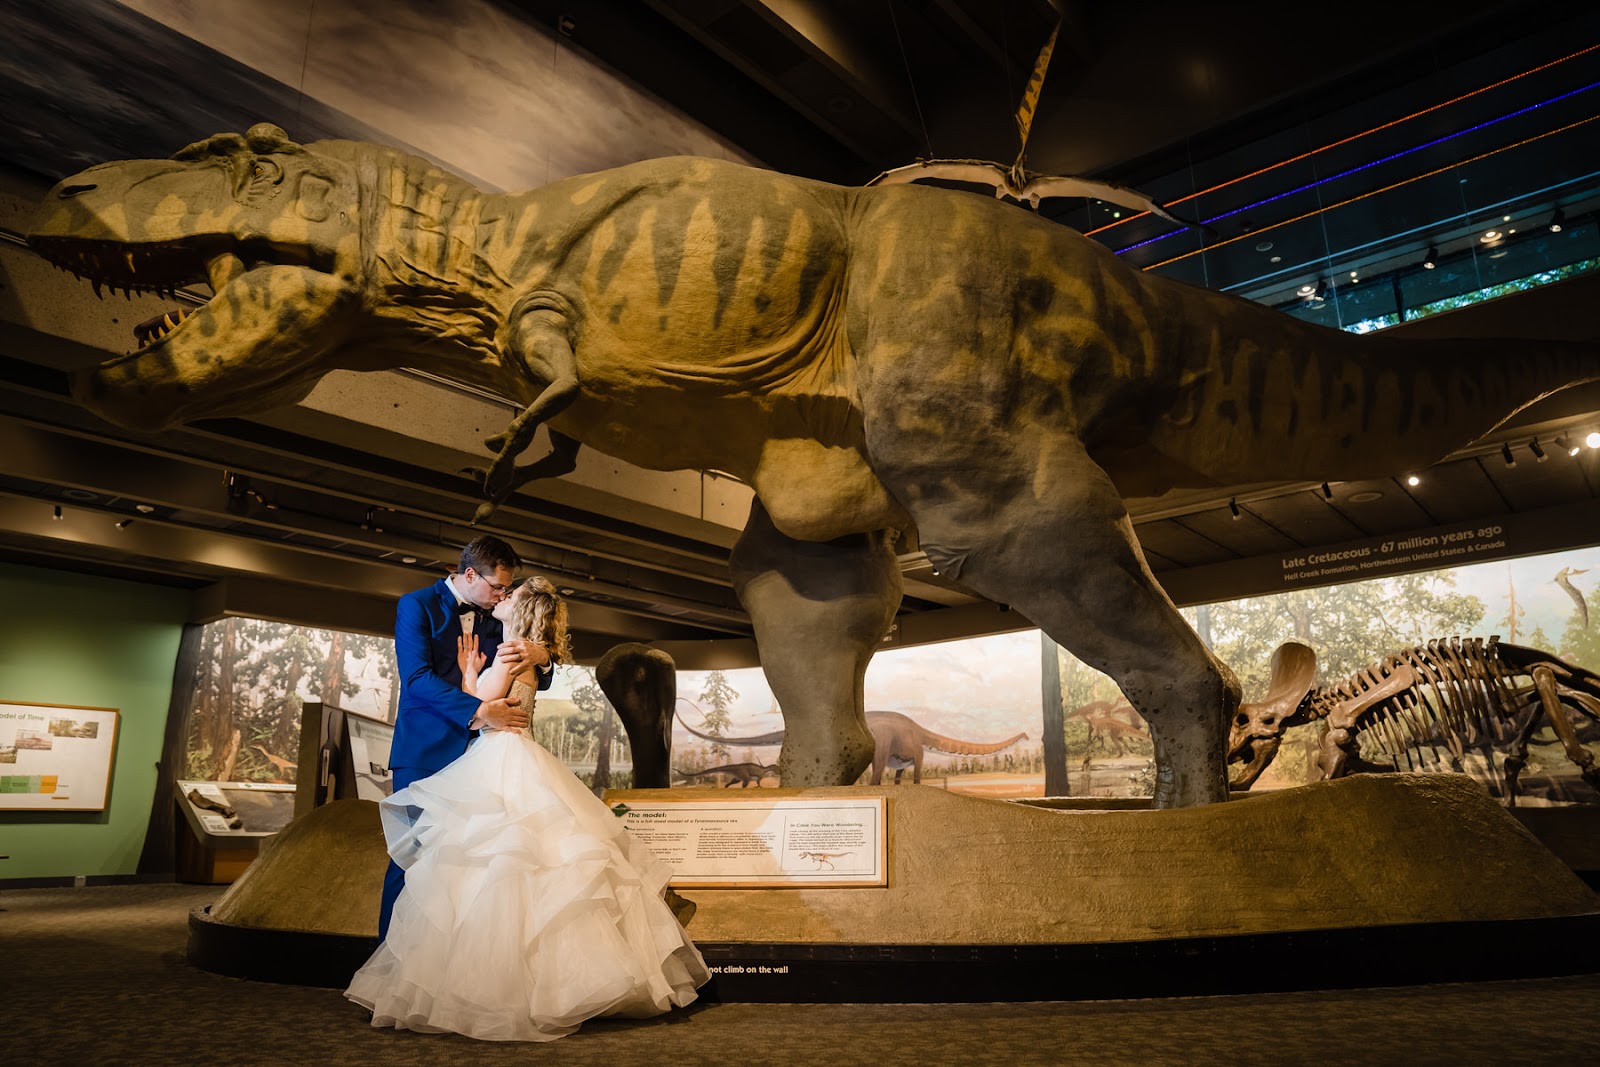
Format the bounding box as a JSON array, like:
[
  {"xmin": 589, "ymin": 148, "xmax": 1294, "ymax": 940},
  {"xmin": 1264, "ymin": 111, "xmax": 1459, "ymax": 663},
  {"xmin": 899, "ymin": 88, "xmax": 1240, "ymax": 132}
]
[{"xmin": 0, "ymin": 0, "xmax": 1600, "ymax": 662}]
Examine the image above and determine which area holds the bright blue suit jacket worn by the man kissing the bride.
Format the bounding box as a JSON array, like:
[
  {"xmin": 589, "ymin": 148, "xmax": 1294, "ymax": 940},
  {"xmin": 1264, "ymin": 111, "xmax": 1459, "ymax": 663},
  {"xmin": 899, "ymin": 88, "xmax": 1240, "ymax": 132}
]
[{"xmin": 389, "ymin": 579, "xmax": 550, "ymax": 777}]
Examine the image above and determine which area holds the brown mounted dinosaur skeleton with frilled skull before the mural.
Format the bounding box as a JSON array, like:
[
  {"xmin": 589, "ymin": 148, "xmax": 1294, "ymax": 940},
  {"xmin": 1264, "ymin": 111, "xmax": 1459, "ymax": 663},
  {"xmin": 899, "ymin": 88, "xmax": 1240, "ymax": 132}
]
[{"xmin": 1227, "ymin": 637, "xmax": 1600, "ymax": 805}]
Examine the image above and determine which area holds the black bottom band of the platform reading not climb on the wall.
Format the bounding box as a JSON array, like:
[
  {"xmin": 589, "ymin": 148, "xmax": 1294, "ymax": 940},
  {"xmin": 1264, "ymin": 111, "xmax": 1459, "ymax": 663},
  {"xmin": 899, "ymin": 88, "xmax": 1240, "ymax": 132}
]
[{"xmin": 187, "ymin": 907, "xmax": 1600, "ymax": 1005}]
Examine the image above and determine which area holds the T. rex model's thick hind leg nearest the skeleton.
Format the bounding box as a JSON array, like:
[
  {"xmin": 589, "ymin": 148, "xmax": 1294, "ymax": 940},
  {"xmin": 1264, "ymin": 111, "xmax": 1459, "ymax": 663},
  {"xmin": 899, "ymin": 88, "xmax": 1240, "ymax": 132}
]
[{"xmin": 867, "ymin": 422, "xmax": 1238, "ymax": 808}]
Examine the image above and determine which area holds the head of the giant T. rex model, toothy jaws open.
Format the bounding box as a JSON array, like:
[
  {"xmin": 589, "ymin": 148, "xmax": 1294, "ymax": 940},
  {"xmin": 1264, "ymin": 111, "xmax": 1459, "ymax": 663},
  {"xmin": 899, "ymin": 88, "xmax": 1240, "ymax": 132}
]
[{"xmin": 27, "ymin": 123, "xmax": 362, "ymax": 429}]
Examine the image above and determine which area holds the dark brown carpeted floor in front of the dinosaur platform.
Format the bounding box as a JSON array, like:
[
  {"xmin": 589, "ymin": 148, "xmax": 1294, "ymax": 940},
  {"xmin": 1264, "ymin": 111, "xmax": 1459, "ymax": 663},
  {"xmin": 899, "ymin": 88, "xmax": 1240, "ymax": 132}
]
[{"xmin": 9, "ymin": 885, "xmax": 1600, "ymax": 1067}]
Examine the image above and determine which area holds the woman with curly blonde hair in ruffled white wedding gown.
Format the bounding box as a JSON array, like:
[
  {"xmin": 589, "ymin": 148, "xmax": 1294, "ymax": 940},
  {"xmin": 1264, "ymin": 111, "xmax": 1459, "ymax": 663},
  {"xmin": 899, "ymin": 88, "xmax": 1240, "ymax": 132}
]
[{"xmin": 344, "ymin": 577, "xmax": 709, "ymax": 1041}]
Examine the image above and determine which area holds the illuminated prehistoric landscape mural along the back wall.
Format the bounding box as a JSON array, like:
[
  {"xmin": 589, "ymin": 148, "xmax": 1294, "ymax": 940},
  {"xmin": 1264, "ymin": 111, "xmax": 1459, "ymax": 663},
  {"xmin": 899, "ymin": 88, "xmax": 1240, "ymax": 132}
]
[{"xmin": 175, "ymin": 549, "xmax": 1600, "ymax": 805}]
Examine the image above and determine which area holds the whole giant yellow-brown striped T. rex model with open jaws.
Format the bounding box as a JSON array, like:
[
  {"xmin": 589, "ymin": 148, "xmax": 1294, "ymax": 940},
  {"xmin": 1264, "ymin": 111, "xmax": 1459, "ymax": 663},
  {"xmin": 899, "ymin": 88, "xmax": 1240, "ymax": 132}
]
[{"xmin": 29, "ymin": 123, "xmax": 1600, "ymax": 806}]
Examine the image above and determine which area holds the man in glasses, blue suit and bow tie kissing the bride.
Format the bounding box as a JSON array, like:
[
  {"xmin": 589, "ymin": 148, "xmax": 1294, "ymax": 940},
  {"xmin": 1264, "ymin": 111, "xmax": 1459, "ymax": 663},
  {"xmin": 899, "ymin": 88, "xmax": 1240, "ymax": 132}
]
[{"xmin": 378, "ymin": 536, "xmax": 550, "ymax": 941}]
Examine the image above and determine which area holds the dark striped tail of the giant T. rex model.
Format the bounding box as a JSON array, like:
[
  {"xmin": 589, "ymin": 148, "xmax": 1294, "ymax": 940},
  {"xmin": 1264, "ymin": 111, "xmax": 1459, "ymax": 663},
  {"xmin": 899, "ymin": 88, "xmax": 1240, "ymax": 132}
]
[{"xmin": 1150, "ymin": 268, "xmax": 1600, "ymax": 486}]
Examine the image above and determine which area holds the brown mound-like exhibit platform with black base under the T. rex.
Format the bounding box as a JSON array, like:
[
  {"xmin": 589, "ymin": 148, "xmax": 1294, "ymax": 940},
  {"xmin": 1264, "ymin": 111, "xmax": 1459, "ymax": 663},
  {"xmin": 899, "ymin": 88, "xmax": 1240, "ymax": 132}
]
[{"xmin": 189, "ymin": 776, "xmax": 1600, "ymax": 1003}]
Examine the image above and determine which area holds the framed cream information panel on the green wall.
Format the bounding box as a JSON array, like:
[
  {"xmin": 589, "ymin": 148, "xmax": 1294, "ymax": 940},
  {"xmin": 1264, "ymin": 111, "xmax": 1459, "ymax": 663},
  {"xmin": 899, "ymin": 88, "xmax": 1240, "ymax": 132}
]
[{"xmin": 0, "ymin": 702, "xmax": 118, "ymax": 811}]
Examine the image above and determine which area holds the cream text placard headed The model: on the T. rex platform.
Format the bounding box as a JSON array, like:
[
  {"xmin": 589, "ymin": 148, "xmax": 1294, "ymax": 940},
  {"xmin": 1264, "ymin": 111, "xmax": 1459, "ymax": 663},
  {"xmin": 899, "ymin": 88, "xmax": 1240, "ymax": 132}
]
[{"xmin": 613, "ymin": 797, "xmax": 888, "ymax": 889}]
